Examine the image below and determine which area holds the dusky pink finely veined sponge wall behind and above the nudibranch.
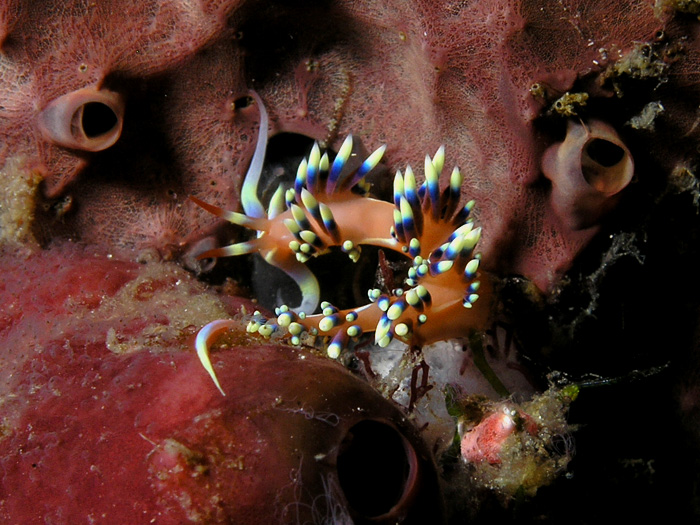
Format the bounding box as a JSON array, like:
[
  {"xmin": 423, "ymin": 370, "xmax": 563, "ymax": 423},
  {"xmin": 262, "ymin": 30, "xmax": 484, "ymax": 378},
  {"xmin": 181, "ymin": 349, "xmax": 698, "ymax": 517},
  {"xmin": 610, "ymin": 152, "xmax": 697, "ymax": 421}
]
[{"xmin": 0, "ymin": 0, "xmax": 698, "ymax": 290}]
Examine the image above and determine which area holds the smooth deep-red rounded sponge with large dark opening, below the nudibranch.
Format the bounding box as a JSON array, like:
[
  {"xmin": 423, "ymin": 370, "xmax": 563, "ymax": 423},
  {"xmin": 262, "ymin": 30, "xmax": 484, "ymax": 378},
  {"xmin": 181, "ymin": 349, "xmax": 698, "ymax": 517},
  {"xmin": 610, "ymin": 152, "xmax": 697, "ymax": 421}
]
[{"xmin": 0, "ymin": 244, "xmax": 442, "ymax": 523}]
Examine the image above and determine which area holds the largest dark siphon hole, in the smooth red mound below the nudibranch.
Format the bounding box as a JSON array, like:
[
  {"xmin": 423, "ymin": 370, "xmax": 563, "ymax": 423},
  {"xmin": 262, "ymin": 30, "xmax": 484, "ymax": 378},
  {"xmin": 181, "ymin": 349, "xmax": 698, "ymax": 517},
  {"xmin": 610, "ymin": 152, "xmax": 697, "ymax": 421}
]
[{"xmin": 338, "ymin": 421, "xmax": 411, "ymax": 518}]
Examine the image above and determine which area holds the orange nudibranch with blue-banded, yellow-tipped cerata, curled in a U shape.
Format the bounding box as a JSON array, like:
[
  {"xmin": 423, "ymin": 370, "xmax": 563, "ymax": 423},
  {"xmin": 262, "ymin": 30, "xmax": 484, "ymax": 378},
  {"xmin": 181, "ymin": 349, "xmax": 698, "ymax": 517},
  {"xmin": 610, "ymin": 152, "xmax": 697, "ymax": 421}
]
[{"xmin": 191, "ymin": 126, "xmax": 489, "ymax": 393}]
